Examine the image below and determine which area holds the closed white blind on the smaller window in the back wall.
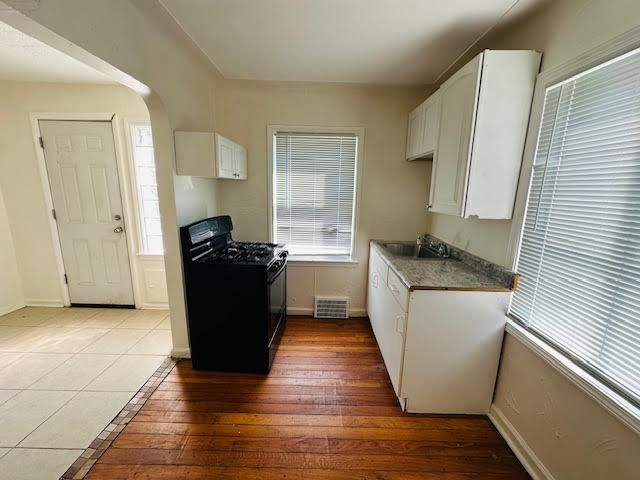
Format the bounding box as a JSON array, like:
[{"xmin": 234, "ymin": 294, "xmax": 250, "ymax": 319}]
[{"xmin": 272, "ymin": 132, "xmax": 358, "ymax": 256}]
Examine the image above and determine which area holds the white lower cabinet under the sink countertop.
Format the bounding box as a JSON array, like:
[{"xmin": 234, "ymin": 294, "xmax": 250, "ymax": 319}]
[{"xmin": 367, "ymin": 248, "xmax": 509, "ymax": 414}]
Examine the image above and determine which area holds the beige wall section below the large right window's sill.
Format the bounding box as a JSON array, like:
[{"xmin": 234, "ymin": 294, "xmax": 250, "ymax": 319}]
[{"xmin": 493, "ymin": 335, "xmax": 640, "ymax": 480}]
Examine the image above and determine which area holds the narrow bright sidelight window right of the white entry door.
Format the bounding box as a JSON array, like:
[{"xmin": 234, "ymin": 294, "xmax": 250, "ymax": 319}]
[{"xmin": 131, "ymin": 125, "xmax": 164, "ymax": 255}]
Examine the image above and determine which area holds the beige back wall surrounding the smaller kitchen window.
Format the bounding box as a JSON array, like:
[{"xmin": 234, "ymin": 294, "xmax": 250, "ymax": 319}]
[{"xmin": 216, "ymin": 80, "xmax": 431, "ymax": 314}]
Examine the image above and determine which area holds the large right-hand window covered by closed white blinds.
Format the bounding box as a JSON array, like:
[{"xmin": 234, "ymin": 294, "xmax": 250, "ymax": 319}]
[{"xmin": 510, "ymin": 50, "xmax": 640, "ymax": 405}]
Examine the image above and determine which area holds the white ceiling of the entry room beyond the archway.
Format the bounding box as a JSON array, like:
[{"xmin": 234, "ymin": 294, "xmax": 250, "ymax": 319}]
[{"xmin": 0, "ymin": 22, "xmax": 114, "ymax": 84}]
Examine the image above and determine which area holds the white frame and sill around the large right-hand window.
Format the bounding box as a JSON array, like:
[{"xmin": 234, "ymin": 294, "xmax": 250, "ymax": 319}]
[{"xmin": 505, "ymin": 27, "xmax": 640, "ymax": 433}]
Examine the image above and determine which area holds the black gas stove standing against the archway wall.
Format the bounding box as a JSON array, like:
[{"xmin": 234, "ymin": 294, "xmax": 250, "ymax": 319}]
[{"xmin": 180, "ymin": 216, "xmax": 287, "ymax": 373}]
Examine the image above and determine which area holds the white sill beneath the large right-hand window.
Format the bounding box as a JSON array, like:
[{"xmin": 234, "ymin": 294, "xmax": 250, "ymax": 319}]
[{"xmin": 506, "ymin": 317, "xmax": 640, "ymax": 434}]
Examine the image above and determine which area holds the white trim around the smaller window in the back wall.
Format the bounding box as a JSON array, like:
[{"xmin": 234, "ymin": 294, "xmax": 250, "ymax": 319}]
[{"xmin": 267, "ymin": 125, "xmax": 364, "ymax": 265}]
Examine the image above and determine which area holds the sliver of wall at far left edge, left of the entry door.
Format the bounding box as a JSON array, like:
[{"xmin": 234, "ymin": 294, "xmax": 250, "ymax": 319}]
[{"xmin": 0, "ymin": 189, "xmax": 24, "ymax": 315}]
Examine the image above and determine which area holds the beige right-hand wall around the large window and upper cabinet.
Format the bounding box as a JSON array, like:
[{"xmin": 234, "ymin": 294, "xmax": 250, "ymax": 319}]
[{"xmin": 430, "ymin": 0, "xmax": 640, "ymax": 480}]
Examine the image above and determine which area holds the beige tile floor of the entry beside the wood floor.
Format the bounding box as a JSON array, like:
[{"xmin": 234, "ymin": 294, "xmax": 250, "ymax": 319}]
[{"xmin": 0, "ymin": 307, "xmax": 171, "ymax": 480}]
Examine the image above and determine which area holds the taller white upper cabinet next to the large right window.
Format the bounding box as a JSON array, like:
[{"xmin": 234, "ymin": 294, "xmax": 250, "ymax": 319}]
[{"xmin": 429, "ymin": 50, "xmax": 540, "ymax": 219}]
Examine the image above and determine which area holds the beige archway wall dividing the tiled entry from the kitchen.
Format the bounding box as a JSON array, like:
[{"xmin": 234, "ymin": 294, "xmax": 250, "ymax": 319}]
[{"xmin": 0, "ymin": 0, "xmax": 221, "ymax": 355}]
